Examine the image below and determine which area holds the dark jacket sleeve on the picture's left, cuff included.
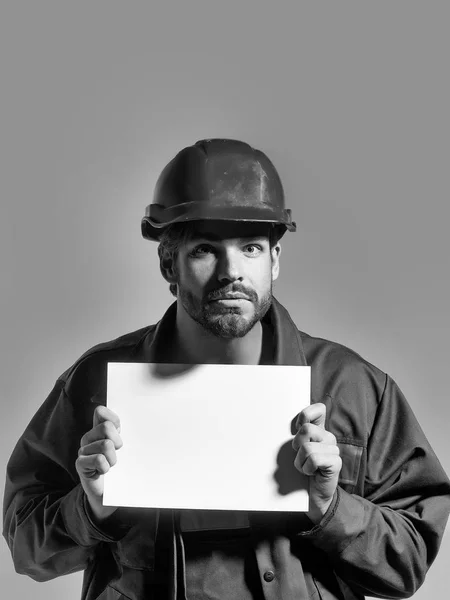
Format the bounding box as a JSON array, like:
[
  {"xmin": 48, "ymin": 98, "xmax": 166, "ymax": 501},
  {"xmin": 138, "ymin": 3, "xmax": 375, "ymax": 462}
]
[{"xmin": 3, "ymin": 380, "xmax": 126, "ymax": 581}]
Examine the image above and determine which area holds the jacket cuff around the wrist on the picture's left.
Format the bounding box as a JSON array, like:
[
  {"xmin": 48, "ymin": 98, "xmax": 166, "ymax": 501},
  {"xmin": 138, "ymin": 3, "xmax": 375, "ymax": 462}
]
[{"xmin": 60, "ymin": 484, "xmax": 131, "ymax": 546}]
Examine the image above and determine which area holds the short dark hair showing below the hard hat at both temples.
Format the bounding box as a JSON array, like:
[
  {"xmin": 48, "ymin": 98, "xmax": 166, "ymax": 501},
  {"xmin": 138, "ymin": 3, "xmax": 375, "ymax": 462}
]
[{"xmin": 158, "ymin": 221, "xmax": 286, "ymax": 297}]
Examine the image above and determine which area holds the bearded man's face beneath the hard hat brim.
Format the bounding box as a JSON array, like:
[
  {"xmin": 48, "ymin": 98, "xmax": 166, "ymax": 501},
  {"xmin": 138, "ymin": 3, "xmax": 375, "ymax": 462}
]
[{"xmin": 171, "ymin": 221, "xmax": 280, "ymax": 339}]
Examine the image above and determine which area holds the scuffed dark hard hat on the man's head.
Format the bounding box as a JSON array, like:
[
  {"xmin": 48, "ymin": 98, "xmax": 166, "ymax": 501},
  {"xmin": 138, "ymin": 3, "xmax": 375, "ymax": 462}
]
[{"xmin": 141, "ymin": 139, "xmax": 296, "ymax": 240}]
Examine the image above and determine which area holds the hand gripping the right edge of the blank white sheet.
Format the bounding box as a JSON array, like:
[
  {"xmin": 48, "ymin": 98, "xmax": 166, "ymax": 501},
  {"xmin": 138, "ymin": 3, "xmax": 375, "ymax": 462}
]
[{"xmin": 292, "ymin": 403, "xmax": 342, "ymax": 524}]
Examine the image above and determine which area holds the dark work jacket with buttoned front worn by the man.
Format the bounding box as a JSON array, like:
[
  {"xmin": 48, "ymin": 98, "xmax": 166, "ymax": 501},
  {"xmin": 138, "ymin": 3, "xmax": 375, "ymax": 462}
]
[{"xmin": 4, "ymin": 300, "xmax": 450, "ymax": 600}]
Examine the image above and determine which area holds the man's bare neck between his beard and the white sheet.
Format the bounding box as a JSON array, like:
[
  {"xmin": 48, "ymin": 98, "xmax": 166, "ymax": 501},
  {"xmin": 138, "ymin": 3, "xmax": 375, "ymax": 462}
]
[{"xmin": 174, "ymin": 301, "xmax": 262, "ymax": 365}]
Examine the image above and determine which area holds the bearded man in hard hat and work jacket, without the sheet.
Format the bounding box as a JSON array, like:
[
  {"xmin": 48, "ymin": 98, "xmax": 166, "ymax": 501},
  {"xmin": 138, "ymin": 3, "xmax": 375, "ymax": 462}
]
[{"xmin": 4, "ymin": 140, "xmax": 450, "ymax": 600}]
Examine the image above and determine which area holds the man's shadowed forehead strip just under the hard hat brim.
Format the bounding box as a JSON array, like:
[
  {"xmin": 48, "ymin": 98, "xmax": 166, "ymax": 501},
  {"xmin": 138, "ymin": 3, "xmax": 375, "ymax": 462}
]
[{"xmin": 185, "ymin": 220, "xmax": 271, "ymax": 241}]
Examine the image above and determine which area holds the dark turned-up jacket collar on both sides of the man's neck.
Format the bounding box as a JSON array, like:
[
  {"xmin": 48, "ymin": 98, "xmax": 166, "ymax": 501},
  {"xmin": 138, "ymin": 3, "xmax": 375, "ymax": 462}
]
[{"xmin": 146, "ymin": 298, "xmax": 307, "ymax": 366}]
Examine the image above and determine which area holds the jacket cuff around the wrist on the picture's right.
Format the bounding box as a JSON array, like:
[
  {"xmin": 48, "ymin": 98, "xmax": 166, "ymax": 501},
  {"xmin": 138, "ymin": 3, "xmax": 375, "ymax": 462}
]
[{"xmin": 298, "ymin": 487, "xmax": 364, "ymax": 554}]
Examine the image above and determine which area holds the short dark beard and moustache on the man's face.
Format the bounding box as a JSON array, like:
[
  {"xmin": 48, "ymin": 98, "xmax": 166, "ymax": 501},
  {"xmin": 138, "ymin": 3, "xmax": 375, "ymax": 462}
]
[{"xmin": 178, "ymin": 284, "xmax": 272, "ymax": 339}]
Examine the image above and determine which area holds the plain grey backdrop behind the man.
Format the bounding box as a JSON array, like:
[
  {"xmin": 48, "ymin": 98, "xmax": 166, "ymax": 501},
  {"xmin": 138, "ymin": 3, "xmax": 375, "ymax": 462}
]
[{"xmin": 0, "ymin": 0, "xmax": 450, "ymax": 600}]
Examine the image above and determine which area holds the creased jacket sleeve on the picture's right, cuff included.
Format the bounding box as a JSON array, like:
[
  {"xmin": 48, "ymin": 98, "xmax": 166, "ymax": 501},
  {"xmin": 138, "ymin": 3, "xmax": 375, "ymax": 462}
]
[{"xmin": 300, "ymin": 377, "xmax": 450, "ymax": 598}]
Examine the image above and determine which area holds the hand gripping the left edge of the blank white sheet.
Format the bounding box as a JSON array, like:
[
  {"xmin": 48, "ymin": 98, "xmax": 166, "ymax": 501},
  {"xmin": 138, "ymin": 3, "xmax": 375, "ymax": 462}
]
[{"xmin": 75, "ymin": 406, "xmax": 123, "ymax": 521}]
